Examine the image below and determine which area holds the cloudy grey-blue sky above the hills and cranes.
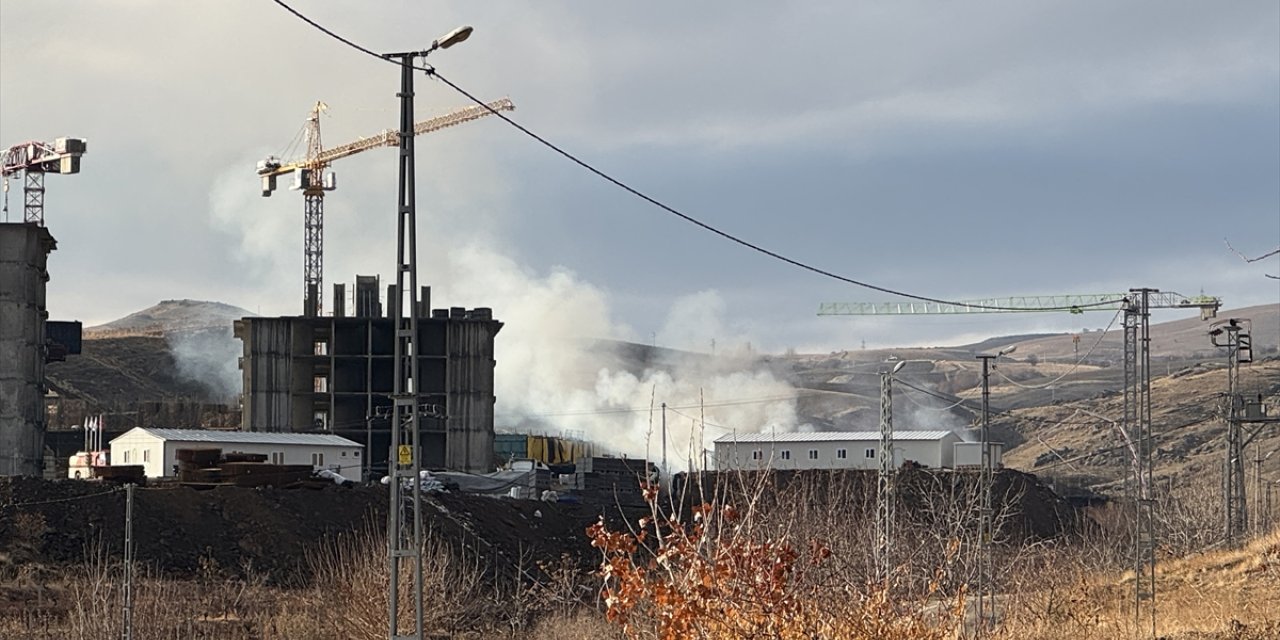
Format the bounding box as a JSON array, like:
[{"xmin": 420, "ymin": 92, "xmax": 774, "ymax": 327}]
[{"xmin": 0, "ymin": 0, "xmax": 1280, "ymax": 349}]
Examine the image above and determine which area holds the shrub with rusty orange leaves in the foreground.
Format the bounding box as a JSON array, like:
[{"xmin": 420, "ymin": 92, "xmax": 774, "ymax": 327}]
[{"xmin": 588, "ymin": 486, "xmax": 959, "ymax": 640}]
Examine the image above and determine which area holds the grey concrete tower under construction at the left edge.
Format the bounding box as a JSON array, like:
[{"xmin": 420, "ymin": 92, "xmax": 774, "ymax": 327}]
[{"xmin": 0, "ymin": 223, "xmax": 58, "ymax": 476}]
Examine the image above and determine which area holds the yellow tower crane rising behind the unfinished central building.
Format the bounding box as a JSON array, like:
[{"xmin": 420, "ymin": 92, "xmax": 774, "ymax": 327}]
[{"xmin": 257, "ymin": 99, "xmax": 516, "ymax": 316}]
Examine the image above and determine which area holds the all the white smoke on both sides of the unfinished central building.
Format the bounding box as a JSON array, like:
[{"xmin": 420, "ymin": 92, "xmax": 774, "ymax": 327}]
[{"xmin": 210, "ymin": 160, "xmax": 796, "ymax": 468}]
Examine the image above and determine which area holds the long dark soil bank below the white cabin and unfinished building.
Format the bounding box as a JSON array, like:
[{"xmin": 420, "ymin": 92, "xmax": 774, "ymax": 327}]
[{"xmin": 0, "ymin": 477, "xmax": 639, "ymax": 585}]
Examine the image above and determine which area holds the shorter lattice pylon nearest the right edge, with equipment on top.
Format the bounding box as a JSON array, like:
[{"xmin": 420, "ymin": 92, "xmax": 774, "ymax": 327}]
[{"xmin": 1208, "ymin": 317, "xmax": 1253, "ymax": 544}]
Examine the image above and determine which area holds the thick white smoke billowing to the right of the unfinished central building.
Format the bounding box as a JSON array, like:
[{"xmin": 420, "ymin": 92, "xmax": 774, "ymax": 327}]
[{"xmin": 438, "ymin": 244, "xmax": 796, "ymax": 468}]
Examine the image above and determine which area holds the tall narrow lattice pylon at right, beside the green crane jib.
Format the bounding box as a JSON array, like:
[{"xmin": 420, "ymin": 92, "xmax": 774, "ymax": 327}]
[{"xmin": 1124, "ymin": 288, "xmax": 1160, "ymax": 637}]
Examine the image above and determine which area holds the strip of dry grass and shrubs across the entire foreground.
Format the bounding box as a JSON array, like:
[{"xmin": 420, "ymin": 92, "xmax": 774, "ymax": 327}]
[{"xmin": 0, "ymin": 480, "xmax": 1280, "ymax": 640}]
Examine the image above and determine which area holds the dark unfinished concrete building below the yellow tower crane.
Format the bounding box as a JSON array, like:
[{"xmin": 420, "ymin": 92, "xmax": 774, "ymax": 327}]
[{"xmin": 236, "ymin": 276, "xmax": 502, "ymax": 472}]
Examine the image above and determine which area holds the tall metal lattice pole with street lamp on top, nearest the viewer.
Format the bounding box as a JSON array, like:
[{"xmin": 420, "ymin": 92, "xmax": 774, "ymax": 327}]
[{"xmin": 383, "ymin": 27, "xmax": 471, "ymax": 640}]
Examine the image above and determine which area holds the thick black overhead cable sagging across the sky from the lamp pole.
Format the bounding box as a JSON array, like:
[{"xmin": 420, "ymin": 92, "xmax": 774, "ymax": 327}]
[{"xmin": 264, "ymin": 0, "xmax": 1123, "ymax": 311}]
